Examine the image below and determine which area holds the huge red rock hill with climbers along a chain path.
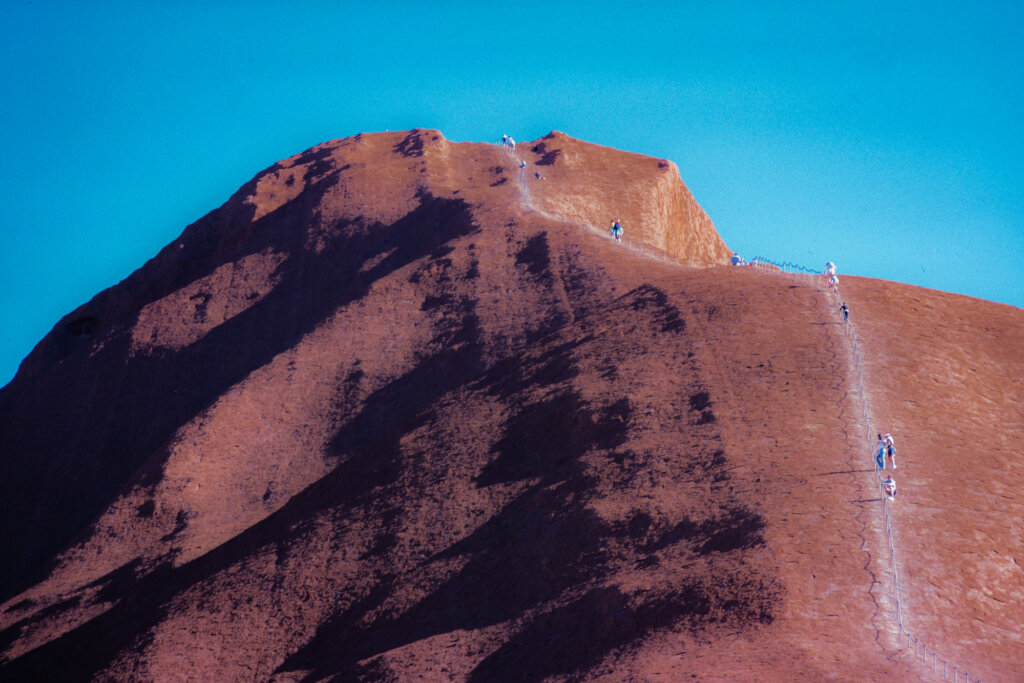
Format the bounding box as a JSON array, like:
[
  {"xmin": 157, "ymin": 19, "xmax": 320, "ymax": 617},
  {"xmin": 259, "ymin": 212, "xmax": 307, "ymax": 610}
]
[{"xmin": 0, "ymin": 130, "xmax": 1024, "ymax": 681}]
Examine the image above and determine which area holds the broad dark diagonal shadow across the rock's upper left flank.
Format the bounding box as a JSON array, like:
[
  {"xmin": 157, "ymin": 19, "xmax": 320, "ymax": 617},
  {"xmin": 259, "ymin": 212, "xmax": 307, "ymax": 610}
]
[{"xmin": 0, "ymin": 175, "xmax": 476, "ymax": 599}]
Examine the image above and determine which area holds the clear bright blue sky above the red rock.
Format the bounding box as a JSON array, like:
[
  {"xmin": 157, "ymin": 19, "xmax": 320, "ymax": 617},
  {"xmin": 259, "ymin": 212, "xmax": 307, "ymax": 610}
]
[{"xmin": 0, "ymin": 0, "xmax": 1024, "ymax": 384}]
